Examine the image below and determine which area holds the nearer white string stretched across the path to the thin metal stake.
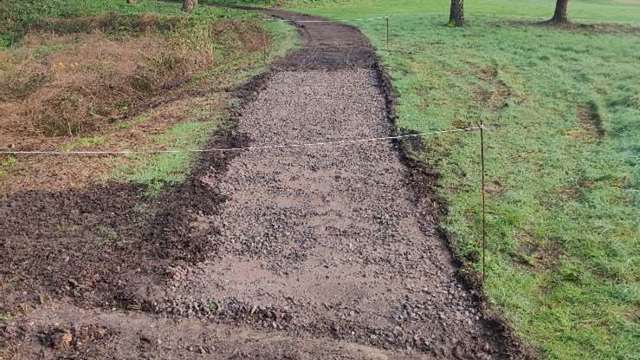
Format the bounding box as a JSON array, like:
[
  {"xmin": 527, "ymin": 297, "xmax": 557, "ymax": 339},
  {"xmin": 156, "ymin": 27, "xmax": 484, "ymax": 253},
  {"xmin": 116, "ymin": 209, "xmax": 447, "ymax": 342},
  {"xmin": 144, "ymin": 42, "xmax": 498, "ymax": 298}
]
[{"xmin": 0, "ymin": 127, "xmax": 486, "ymax": 156}]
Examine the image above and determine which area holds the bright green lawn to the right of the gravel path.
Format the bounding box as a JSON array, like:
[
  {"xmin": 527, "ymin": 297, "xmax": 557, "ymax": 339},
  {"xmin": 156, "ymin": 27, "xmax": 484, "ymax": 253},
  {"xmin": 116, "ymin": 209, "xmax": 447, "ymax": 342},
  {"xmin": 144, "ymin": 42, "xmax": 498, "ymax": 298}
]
[{"xmin": 286, "ymin": 0, "xmax": 640, "ymax": 359}]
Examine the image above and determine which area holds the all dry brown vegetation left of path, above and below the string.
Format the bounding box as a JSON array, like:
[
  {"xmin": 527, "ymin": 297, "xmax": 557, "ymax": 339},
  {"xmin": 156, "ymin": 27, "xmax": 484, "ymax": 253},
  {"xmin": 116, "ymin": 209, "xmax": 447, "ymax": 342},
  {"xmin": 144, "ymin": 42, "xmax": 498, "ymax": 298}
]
[{"xmin": 0, "ymin": 15, "xmax": 270, "ymax": 193}]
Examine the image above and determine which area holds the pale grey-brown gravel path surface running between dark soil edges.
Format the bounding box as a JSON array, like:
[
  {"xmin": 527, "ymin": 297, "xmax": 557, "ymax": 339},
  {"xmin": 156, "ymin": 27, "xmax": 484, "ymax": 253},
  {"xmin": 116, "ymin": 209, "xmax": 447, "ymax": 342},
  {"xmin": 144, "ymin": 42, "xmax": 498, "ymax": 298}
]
[{"xmin": 140, "ymin": 9, "xmax": 510, "ymax": 359}]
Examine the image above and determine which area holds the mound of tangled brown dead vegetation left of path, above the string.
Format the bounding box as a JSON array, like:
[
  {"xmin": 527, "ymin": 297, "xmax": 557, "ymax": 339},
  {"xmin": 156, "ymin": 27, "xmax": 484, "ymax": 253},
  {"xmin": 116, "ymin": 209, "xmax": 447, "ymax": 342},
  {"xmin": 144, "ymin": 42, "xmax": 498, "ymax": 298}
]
[{"xmin": 0, "ymin": 16, "xmax": 262, "ymax": 141}]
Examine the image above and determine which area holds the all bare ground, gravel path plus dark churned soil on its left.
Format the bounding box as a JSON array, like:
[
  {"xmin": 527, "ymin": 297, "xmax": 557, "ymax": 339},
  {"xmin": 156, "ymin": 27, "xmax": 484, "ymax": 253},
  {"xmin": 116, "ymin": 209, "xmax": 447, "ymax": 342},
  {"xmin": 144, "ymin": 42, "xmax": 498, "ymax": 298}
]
[{"xmin": 0, "ymin": 6, "xmax": 524, "ymax": 359}]
